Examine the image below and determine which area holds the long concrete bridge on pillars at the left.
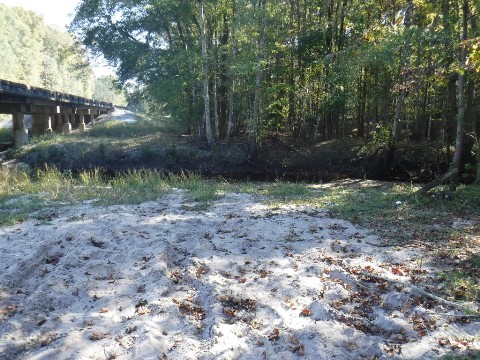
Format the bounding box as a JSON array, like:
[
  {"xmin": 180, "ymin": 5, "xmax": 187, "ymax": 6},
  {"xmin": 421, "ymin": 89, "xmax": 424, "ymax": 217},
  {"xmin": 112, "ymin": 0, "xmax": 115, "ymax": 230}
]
[{"xmin": 0, "ymin": 80, "xmax": 113, "ymax": 147}]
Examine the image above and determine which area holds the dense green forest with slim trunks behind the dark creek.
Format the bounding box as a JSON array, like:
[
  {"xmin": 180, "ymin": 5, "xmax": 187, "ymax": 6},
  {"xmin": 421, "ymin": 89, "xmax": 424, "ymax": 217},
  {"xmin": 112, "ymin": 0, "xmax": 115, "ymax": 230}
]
[{"xmin": 71, "ymin": 0, "xmax": 480, "ymax": 186}]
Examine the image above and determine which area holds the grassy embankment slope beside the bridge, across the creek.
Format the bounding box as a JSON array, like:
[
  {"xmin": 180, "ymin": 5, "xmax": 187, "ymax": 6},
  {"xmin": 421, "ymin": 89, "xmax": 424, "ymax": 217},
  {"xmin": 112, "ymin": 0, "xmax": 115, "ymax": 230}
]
[{"xmin": 10, "ymin": 114, "xmax": 181, "ymax": 169}]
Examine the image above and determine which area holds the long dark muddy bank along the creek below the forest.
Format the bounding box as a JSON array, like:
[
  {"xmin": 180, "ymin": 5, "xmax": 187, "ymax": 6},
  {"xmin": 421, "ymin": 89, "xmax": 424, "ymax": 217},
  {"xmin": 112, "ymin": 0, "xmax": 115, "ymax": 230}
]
[{"xmin": 15, "ymin": 140, "xmax": 448, "ymax": 182}]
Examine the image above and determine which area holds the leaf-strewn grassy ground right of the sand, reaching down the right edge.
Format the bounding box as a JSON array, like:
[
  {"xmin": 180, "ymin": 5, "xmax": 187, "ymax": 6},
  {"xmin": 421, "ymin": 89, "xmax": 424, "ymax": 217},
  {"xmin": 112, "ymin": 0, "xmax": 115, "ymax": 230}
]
[{"xmin": 258, "ymin": 181, "xmax": 480, "ymax": 303}]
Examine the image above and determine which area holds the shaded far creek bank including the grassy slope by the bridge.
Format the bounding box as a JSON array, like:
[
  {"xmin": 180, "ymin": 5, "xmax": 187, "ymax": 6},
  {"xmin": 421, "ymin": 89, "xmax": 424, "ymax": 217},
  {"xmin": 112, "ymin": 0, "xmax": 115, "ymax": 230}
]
[{"xmin": 9, "ymin": 114, "xmax": 454, "ymax": 182}]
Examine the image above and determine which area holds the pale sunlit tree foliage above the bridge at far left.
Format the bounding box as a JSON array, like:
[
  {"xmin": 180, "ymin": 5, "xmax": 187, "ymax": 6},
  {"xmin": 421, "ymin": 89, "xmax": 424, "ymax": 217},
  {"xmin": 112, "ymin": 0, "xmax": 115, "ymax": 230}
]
[{"xmin": 0, "ymin": 4, "xmax": 93, "ymax": 98}]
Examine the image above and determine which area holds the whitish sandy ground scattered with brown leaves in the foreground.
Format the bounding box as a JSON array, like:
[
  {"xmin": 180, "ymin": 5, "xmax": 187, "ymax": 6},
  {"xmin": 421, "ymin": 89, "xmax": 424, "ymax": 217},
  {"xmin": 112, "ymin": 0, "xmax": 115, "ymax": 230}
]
[{"xmin": 0, "ymin": 190, "xmax": 480, "ymax": 359}]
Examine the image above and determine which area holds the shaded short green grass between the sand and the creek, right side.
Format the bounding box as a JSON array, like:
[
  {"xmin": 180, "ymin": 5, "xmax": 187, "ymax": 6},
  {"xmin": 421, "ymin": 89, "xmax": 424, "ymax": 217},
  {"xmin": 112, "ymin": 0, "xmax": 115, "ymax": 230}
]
[{"xmin": 255, "ymin": 182, "xmax": 480, "ymax": 242}]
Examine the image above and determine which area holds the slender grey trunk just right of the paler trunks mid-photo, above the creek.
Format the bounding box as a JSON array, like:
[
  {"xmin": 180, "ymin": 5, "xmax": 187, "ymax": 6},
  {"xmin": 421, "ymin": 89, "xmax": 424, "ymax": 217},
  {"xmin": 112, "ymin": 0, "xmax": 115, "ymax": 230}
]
[{"xmin": 250, "ymin": 0, "xmax": 267, "ymax": 157}]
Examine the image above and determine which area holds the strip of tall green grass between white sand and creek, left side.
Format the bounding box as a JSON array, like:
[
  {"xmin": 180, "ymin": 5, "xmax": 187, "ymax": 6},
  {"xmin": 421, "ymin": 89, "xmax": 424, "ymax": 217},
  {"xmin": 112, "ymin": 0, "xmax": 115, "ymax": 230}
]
[{"xmin": 0, "ymin": 168, "xmax": 224, "ymax": 225}]
